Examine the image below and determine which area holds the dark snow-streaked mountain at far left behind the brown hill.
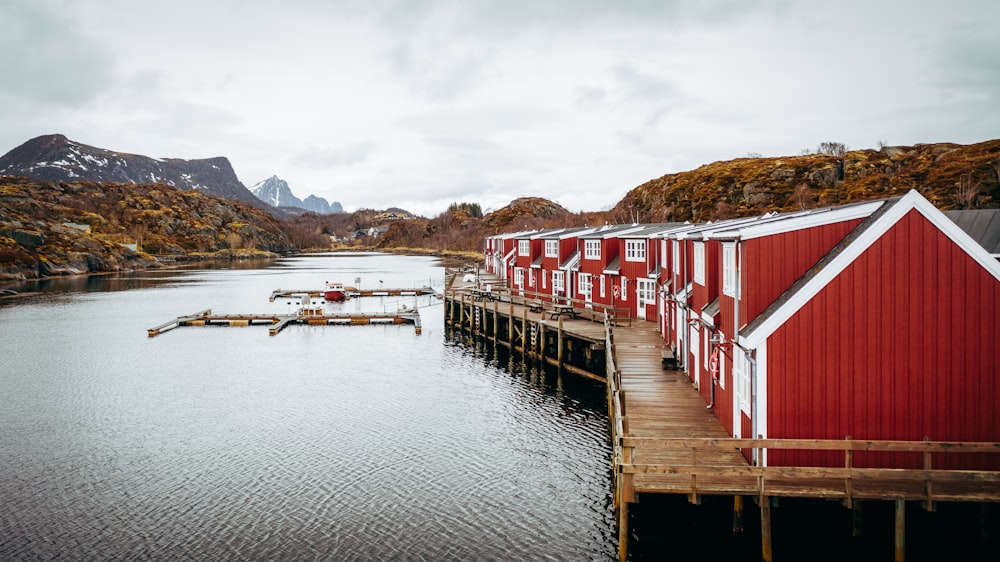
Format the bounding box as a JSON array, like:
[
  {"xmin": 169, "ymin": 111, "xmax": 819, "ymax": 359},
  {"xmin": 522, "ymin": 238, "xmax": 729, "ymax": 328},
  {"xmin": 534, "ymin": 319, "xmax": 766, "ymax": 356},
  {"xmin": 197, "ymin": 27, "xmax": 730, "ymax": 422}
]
[{"xmin": 0, "ymin": 134, "xmax": 266, "ymax": 210}]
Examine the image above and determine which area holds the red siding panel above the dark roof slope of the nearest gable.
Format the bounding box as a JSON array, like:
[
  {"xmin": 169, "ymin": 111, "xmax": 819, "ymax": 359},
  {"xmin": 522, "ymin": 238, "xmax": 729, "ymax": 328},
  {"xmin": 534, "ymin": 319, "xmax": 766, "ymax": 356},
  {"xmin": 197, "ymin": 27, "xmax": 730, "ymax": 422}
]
[{"xmin": 739, "ymin": 219, "xmax": 863, "ymax": 325}]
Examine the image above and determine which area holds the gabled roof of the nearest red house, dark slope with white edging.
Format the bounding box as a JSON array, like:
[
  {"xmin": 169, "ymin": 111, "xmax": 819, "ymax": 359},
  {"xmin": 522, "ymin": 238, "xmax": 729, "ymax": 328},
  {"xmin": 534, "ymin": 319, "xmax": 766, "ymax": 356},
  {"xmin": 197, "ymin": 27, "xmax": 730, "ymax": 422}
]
[{"xmin": 740, "ymin": 190, "xmax": 1000, "ymax": 349}]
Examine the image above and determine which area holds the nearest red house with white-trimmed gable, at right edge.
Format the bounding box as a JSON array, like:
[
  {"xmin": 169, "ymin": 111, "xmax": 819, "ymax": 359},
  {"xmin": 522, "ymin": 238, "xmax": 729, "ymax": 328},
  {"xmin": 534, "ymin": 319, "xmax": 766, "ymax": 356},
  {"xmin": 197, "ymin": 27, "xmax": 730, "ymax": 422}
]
[{"xmin": 711, "ymin": 191, "xmax": 1000, "ymax": 468}]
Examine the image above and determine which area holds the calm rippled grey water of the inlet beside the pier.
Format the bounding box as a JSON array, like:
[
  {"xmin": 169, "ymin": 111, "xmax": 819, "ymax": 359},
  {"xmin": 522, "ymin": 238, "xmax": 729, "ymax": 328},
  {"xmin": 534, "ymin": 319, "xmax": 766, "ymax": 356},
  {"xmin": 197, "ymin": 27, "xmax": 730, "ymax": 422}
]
[{"xmin": 0, "ymin": 254, "xmax": 616, "ymax": 560}]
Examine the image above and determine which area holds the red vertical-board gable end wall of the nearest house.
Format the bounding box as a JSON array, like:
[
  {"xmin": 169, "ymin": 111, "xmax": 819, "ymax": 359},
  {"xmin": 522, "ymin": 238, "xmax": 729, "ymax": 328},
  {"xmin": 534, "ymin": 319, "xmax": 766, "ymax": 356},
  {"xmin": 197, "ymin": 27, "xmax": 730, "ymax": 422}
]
[{"xmin": 767, "ymin": 211, "xmax": 1000, "ymax": 468}]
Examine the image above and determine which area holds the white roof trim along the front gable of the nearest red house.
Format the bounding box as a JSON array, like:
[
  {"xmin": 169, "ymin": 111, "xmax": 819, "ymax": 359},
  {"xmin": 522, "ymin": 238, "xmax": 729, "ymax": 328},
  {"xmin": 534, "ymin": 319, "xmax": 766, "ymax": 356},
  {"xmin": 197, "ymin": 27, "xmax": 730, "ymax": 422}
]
[{"xmin": 740, "ymin": 190, "xmax": 1000, "ymax": 349}]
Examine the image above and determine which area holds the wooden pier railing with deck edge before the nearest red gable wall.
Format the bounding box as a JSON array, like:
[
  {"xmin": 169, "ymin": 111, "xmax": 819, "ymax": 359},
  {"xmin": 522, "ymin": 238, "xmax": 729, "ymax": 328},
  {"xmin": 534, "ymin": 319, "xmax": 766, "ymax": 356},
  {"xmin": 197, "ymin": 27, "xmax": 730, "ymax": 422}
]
[{"xmin": 609, "ymin": 434, "xmax": 1000, "ymax": 508}]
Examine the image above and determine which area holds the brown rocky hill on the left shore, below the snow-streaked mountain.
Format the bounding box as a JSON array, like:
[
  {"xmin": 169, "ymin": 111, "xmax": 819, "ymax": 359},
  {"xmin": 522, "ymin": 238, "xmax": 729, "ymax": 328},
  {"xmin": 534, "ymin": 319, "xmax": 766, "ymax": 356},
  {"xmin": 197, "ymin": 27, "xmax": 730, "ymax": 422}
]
[{"xmin": 0, "ymin": 177, "xmax": 294, "ymax": 280}]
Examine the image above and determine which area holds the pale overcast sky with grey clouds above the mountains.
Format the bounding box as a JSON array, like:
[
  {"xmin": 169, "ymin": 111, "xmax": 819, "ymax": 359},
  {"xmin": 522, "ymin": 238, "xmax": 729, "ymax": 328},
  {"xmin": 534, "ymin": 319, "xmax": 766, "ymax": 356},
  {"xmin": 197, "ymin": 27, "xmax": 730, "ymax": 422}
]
[{"xmin": 0, "ymin": 0, "xmax": 1000, "ymax": 217}]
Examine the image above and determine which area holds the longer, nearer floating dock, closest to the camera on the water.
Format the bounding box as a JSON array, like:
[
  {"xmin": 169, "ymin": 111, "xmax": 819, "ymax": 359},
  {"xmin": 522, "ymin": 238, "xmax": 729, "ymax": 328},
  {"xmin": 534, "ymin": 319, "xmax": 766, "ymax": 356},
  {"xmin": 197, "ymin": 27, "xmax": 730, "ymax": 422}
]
[{"xmin": 146, "ymin": 308, "xmax": 420, "ymax": 338}]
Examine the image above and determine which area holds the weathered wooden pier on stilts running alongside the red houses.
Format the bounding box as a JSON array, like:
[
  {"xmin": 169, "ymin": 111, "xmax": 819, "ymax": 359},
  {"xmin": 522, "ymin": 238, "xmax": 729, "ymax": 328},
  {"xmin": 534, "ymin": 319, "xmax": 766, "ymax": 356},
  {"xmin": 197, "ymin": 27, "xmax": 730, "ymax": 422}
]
[{"xmin": 445, "ymin": 279, "xmax": 1000, "ymax": 562}]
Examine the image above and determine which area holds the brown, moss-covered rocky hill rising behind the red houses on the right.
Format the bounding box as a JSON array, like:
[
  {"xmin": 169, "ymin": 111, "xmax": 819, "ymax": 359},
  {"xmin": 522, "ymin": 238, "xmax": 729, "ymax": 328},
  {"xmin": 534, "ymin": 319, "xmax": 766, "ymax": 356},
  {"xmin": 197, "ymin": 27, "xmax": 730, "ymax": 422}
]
[{"xmin": 612, "ymin": 140, "xmax": 1000, "ymax": 222}]
